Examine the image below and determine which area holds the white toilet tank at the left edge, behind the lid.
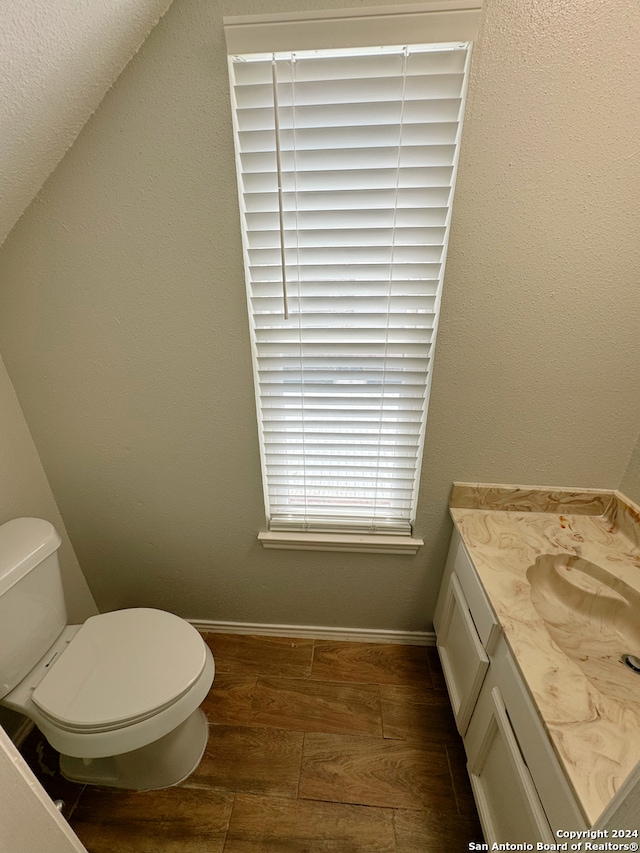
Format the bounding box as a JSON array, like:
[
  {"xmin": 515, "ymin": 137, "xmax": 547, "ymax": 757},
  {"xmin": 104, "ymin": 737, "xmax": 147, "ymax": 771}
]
[{"xmin": 0, "ymin": 518, "xmax": 67, "ymax": 698}]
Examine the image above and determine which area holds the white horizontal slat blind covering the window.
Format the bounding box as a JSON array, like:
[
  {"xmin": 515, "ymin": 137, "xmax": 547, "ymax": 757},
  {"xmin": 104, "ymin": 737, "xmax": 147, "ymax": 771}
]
[{"xmin": 229, "ymin": 43, "xmax": 470, "ymax": 534}]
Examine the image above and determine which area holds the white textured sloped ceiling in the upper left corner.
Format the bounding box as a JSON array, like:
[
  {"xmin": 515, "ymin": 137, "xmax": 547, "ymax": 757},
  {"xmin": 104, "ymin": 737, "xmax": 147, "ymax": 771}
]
[{"xmin": 0, "ymin": 0, "xmax": 171, "ymax": 243}]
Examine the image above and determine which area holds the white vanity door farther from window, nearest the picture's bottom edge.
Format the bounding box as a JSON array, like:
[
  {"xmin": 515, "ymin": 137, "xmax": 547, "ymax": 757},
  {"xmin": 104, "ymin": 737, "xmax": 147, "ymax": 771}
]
[{"xmin": 466, "ymin": 682, "xmax": 554, "ymax": 844}]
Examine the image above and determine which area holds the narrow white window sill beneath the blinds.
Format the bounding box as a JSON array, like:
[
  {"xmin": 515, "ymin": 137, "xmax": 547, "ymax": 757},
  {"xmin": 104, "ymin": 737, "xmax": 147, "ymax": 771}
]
[{"xmin": 258, "ymin": 531, "xmax": 424, "ymax": 556}]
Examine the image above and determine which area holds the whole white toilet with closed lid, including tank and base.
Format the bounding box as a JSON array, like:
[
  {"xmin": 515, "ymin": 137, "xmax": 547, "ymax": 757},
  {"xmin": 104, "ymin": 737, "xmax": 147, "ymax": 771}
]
[{"xmin": 0, "ymin": 518, "xmax": 215, "ymax": 791}]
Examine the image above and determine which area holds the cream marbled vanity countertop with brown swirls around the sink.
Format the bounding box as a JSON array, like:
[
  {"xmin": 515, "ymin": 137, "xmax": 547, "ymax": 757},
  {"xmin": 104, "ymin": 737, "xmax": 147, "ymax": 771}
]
[{"xmin": 450, "ymin": 484, "xmax": 640, "ymax": 825}]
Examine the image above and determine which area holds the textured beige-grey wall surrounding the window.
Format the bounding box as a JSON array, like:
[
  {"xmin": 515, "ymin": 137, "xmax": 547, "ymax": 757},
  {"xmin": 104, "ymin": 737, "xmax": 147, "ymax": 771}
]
[{"xmin": 0, "ymin": 0, "xmax": 640, "ymax": 630}]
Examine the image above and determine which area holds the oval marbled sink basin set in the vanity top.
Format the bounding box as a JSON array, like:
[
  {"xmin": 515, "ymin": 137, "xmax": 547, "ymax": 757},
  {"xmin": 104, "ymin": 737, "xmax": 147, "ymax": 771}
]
[{"xmin": 527, "ymin": 554, "xmax": 640, "ymax": 704}]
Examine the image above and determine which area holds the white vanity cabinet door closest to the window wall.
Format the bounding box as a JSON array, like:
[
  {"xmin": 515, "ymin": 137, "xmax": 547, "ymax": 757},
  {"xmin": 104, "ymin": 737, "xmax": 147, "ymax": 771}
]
[{"xmin": 437, "ymin": 572, "xmax": 489, "ymax": 734}]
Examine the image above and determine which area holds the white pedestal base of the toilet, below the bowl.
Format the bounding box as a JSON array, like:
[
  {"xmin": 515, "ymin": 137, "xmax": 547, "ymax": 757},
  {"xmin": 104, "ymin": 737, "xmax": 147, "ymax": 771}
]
[{"xmin": 60, "ymin": 708, "xmax": 209, "ymax": 791}]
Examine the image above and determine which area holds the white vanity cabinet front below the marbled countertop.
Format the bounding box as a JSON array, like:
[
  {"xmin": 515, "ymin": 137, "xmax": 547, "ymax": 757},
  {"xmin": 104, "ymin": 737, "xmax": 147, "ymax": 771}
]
[{"xmin": 434, "ymin": 531, "xmax": 587, "ymax": 843}]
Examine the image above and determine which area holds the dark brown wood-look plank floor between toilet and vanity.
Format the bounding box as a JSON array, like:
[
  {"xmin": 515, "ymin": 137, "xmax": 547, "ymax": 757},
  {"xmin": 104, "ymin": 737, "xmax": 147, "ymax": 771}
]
[{"xmin": 23, "ymin": 634, "xmax": 482, "ymax": 853}]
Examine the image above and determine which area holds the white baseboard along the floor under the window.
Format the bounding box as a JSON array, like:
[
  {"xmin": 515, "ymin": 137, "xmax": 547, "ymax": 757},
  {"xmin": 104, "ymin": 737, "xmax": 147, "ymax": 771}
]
[{"xmin": 189, "ymin": 619, "xmax": 436, "ymax": 646}]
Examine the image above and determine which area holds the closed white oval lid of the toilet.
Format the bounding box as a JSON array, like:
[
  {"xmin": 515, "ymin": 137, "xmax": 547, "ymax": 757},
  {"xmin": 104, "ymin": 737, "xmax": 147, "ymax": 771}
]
[{"xmin": 33, "ymin": 608, "xmax": 206, "ymax": 731}]
